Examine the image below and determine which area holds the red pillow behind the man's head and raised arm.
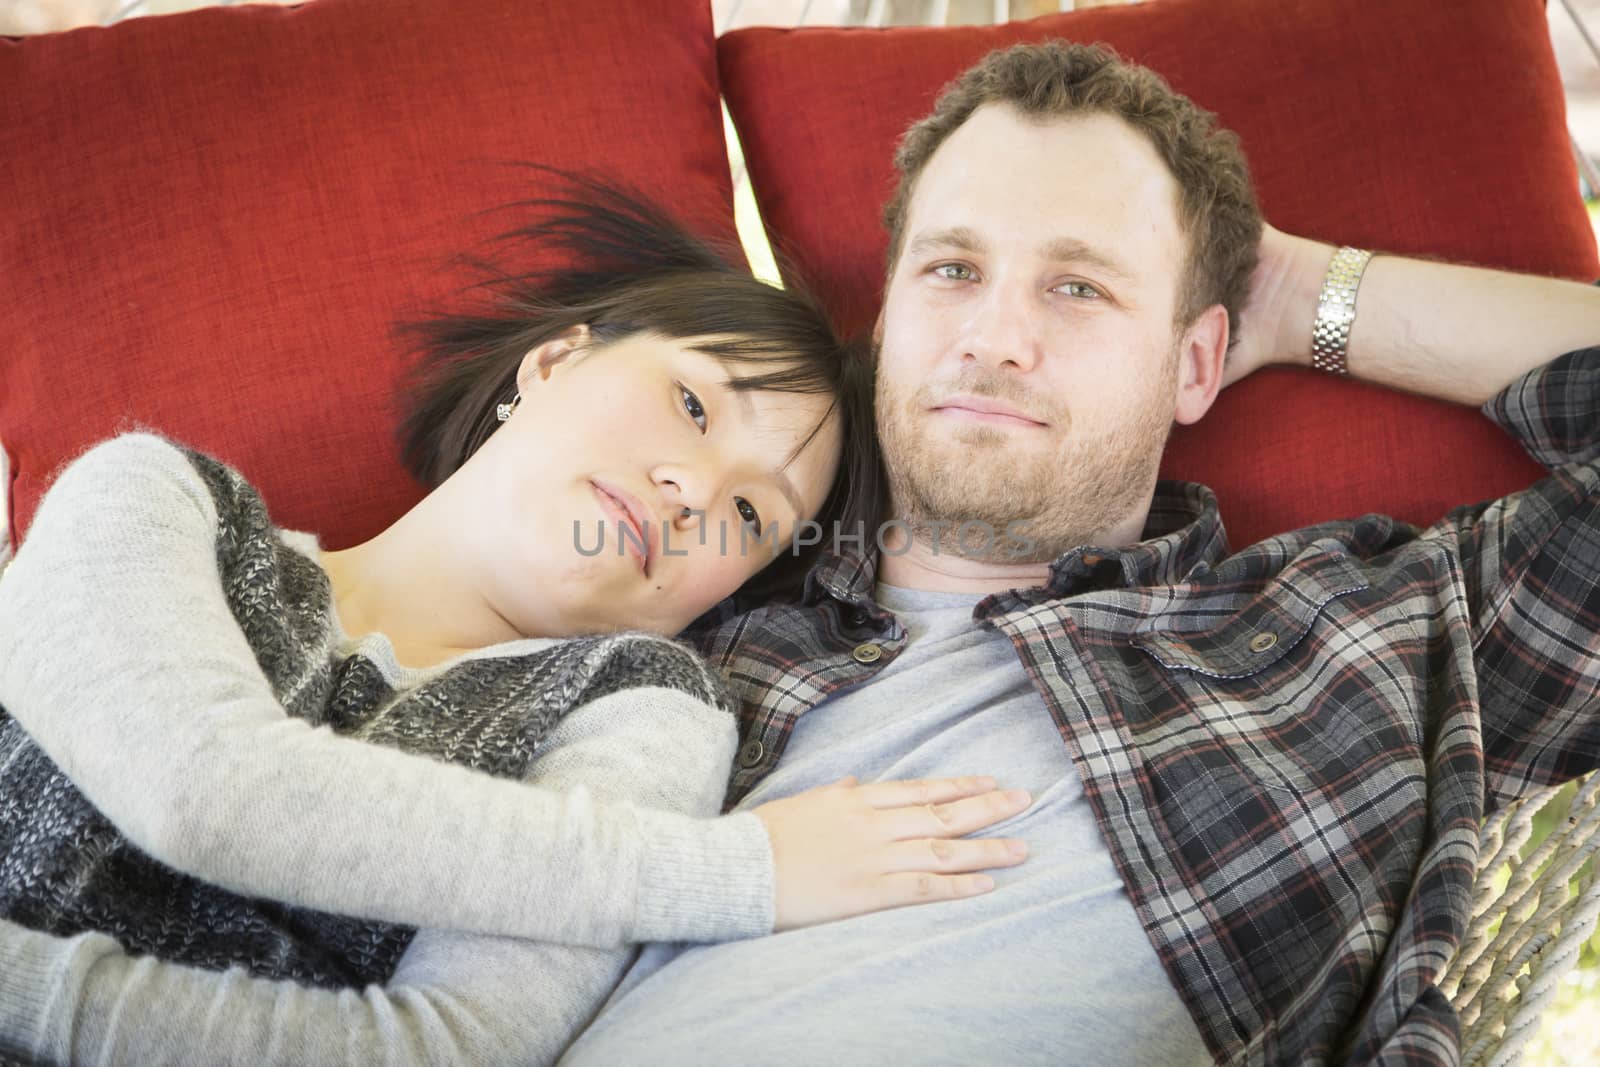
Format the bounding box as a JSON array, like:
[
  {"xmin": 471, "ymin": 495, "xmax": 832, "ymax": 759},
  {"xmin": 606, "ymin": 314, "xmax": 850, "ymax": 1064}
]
[{"xmin": 718, "ymin": 0, "xmax": 1600, "ymax": 545}]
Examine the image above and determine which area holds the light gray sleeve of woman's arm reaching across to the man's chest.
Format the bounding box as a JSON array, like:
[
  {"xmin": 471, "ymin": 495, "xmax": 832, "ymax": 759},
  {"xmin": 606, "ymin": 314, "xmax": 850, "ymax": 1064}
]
[{"xmin": 0, "ymin": 435, "xmax": 774, "ymax": 947}]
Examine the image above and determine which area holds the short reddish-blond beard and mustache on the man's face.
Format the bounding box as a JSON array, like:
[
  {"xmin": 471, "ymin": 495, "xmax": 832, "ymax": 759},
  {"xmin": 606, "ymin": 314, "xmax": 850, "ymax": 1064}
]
[{"xmin": 877, "ymin": 347, "xmax": 1178, "ymax": 563}]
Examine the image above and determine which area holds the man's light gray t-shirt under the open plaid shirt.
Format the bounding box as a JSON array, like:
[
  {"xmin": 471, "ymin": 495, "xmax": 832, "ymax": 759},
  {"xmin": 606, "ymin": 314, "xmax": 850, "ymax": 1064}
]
[{"xmin": 562, "ymin": 587, "xmax": 1210, "ymax": 1067}]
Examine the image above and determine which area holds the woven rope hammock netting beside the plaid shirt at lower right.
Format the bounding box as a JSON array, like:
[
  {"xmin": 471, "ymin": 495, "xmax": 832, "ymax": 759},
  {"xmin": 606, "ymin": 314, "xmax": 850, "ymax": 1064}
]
[{"xmin": 1440, "ymin": 773, "xmax": 1600, "ymax": 1067}]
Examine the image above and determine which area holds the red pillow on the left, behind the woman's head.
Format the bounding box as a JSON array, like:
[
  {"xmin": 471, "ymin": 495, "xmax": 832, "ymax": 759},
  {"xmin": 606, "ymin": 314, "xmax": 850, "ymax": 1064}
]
[{"xmin": 0, "ymin": 0, "xmax": 733, "ymax": 547}]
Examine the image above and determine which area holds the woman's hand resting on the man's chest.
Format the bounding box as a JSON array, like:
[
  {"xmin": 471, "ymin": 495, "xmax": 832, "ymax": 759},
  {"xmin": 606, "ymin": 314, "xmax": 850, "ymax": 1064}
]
[{"xmin": 754, "ymin": 776, "xmax": 1032, "ymax": 929}]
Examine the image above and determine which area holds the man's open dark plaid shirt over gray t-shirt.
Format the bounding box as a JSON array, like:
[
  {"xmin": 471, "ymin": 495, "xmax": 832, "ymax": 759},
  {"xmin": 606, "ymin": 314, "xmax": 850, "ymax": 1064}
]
[{"xmin": 698, "ymin": 347, "xmax": 1600, "ymax": 1064}]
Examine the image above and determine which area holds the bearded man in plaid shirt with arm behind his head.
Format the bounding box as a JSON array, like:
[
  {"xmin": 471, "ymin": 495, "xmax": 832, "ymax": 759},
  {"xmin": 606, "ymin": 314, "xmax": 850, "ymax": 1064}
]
[{"xmin": 563, "ymin": 37, "xmax": 1600, "ymax": 1065}]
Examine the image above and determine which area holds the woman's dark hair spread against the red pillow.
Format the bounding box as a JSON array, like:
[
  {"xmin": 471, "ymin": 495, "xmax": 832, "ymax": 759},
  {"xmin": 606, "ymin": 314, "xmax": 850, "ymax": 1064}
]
[{"xmin": 398, "ymin": 165, "xmax": 886, "ymax": 597}]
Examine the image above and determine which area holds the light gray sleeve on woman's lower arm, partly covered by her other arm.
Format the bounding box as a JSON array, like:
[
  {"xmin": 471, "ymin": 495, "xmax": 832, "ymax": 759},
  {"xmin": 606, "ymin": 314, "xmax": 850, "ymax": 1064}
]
[{"xmin": 0, "ymin": 689, "xmax": 734, "ymax": 1067}]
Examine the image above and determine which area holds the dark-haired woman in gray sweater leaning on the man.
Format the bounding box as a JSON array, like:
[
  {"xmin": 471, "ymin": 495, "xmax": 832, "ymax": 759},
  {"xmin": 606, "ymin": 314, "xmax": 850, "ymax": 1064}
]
[{"xmin": 0, "ymin": 186, "xmax": 1021, "ymax": 1064}]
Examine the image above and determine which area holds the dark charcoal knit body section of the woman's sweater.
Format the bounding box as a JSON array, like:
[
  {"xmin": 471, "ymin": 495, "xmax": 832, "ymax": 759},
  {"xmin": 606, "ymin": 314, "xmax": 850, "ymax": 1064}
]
[{"xmin": 0, "ymin": 453, "xmax": 728, "ymax": 987}]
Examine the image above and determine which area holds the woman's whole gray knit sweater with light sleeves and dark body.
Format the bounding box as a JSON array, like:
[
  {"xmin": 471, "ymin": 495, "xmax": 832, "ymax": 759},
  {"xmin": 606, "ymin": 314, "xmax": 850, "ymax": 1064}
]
[{"xmin": 0, "ymin": 435, "xmax": 771, "ymax": 1062}]
